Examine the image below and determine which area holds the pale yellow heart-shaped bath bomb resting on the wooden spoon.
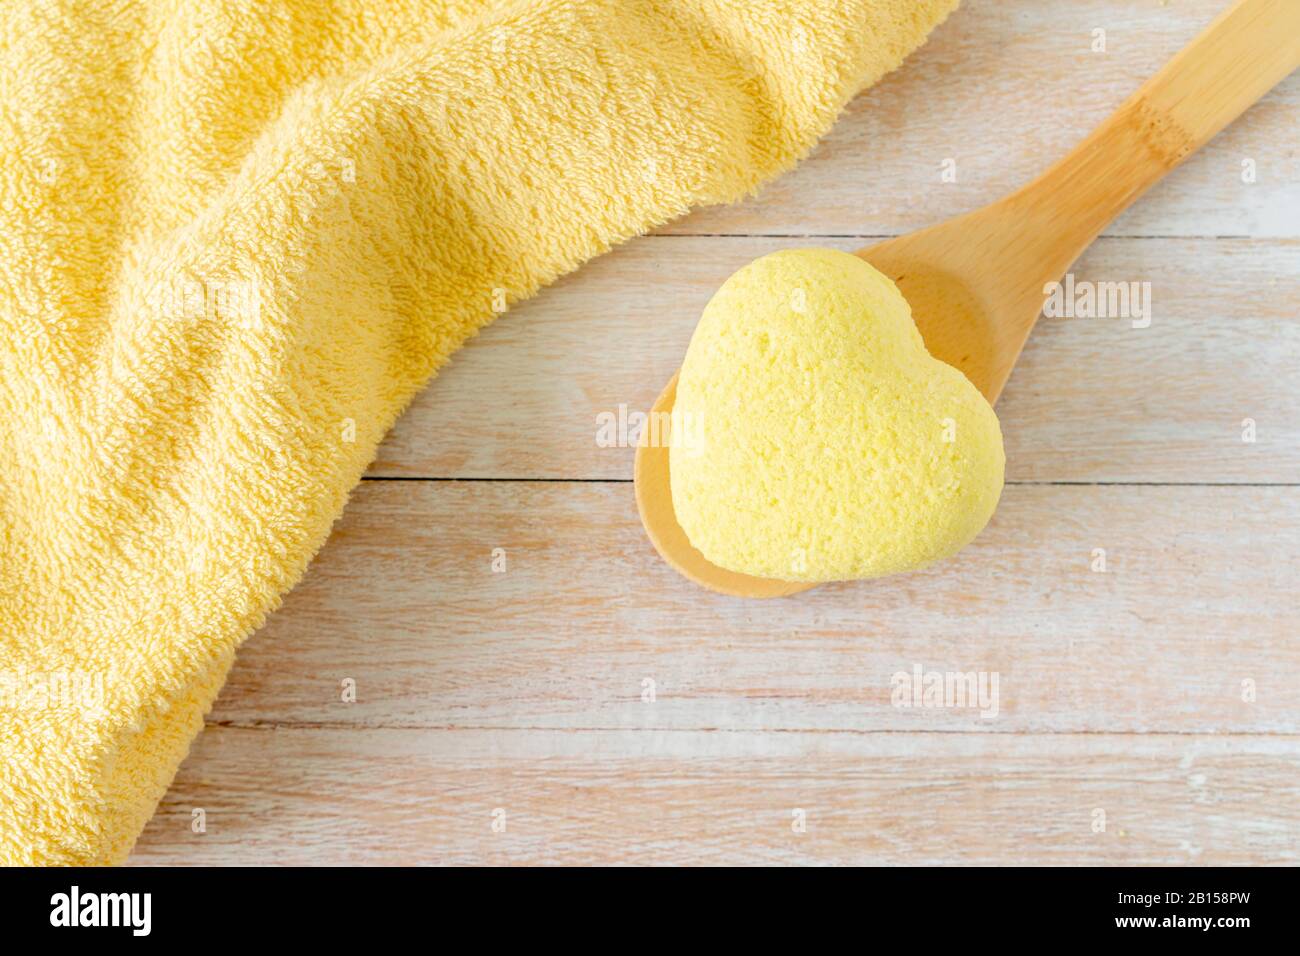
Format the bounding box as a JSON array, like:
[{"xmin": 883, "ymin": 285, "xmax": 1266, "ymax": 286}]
[{"xmin": 668, "ymin": 248, "xmax": 1005, "ymax": 581}]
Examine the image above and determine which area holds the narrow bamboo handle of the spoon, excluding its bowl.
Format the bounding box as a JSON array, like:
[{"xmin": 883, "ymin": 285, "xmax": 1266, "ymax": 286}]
[{"xmin": 1006, "ymin": 0, "xmax": 1300, "ymax": 257}]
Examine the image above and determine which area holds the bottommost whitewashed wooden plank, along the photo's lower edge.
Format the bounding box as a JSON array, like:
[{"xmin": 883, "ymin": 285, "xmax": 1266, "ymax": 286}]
[{"xmin": 133, "ymin": 727, "xmax": 1300, "ymax": 866}]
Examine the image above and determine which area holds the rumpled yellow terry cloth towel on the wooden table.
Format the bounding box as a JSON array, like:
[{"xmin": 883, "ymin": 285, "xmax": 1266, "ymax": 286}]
[{"xmin": 0, "ymin": 0, "xmax": 956, "ymax": 864}]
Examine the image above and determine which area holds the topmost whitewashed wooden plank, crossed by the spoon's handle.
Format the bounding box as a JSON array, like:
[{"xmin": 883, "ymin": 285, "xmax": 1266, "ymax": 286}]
[{"xmin": 666, "ymin": 0, "xmax": 1300, "ymax": 238}]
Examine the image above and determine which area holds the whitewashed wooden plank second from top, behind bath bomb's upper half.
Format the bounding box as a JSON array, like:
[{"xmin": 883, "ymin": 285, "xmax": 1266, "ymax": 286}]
[{"xmin": 371, "ymin": 237, "xmax": 1300, "ymax": 483}]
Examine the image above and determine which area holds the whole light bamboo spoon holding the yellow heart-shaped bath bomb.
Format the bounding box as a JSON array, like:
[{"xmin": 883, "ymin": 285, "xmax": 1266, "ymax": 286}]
[{"xmin": 633, "ymin": 0, "xmax": 1300, "ymax": 597}]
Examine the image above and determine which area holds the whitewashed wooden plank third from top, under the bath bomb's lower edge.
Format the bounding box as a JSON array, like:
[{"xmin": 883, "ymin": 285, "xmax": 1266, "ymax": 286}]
[{"xmin": 212, "ymin": 481, "xmax": 1300, "ymax": 734}]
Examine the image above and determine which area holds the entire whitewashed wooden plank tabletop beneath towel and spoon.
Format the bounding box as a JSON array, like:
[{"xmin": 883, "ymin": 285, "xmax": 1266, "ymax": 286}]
[{"xmin": 133, "ymin": 0, "xmax": 1300, "ymax": 864}]
